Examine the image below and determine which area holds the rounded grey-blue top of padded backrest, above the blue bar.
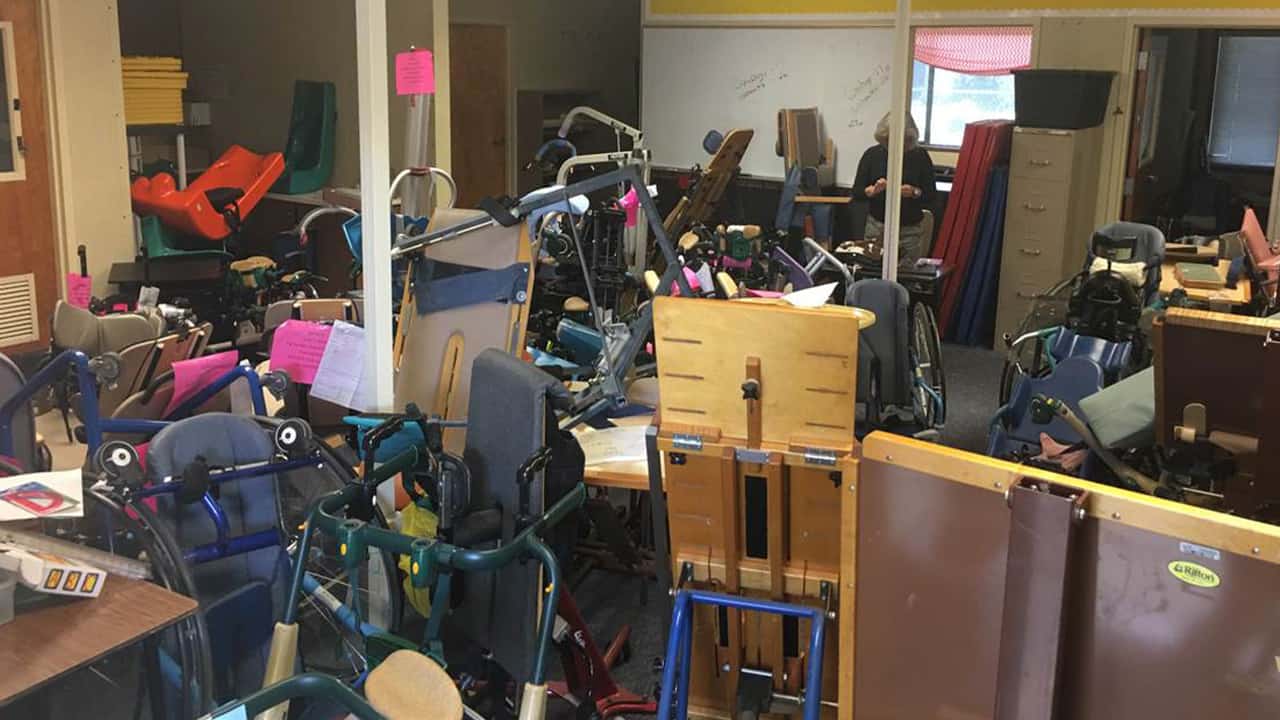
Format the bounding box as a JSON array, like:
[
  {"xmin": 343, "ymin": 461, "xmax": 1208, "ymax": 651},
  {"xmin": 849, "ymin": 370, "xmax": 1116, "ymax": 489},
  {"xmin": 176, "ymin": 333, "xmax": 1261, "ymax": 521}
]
[{"xmin": 147, "ymin": 413, "xmax": 275, "ymax": 477}]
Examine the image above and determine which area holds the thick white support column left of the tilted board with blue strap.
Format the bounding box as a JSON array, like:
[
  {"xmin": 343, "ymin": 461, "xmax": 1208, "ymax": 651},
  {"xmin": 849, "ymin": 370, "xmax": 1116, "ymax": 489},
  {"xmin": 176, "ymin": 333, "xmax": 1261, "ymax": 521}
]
[{"xmin": 356, "ymin": 0, "xmax": 394, "ymax": 411}]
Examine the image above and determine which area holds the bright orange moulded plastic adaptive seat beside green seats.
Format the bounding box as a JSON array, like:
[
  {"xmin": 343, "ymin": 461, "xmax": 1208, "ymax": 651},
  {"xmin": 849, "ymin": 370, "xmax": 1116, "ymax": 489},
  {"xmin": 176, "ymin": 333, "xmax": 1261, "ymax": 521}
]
[{"xmin": 131, "ymin": 145, "xmax": 284, "ymax": 240}]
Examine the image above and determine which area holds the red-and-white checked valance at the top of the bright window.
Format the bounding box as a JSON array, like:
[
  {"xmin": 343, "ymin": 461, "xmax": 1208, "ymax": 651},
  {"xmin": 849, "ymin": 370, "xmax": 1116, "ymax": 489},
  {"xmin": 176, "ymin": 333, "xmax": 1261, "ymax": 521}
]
[{"xmin": 915, "ymin": 27, "xmax": 1032, "ymax": 76}]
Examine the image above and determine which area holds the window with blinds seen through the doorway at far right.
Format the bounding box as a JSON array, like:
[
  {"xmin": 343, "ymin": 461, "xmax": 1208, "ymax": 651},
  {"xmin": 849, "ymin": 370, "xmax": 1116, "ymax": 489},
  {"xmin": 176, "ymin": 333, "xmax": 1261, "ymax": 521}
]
[{"xmin": 1208, "ymin": 35, "xmax": 1280, "ymax": 168}]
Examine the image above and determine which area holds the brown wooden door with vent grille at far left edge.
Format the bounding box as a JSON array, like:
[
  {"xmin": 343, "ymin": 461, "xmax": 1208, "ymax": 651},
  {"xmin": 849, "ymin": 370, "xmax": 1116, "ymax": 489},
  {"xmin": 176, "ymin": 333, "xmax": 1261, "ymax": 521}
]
[{"xmin": 0, "ymin": 0, "xmax": 59, "ymax": 352}]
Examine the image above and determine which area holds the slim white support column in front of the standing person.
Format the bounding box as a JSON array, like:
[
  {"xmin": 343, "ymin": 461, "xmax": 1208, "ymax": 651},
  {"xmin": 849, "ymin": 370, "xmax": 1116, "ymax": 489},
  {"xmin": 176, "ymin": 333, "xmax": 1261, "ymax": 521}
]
[{"xmin": 881, "ymin": 0, "xmax": 911, "ymax": 281}]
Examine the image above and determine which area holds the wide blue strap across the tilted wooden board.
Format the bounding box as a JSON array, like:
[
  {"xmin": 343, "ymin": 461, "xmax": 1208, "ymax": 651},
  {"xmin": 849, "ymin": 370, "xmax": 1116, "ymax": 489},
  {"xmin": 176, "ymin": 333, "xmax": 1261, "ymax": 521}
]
[{"xmin": 413, "ymin": 260, "xmax": 529, "ymax": 315}]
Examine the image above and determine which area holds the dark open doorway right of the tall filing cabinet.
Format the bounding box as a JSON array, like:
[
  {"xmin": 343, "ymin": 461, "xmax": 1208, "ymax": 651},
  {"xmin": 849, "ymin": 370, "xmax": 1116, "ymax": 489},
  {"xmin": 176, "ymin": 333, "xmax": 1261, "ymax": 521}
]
[{"xmin": 1123, "ymin": 28, "xmax": 1280, "ymax": 240}]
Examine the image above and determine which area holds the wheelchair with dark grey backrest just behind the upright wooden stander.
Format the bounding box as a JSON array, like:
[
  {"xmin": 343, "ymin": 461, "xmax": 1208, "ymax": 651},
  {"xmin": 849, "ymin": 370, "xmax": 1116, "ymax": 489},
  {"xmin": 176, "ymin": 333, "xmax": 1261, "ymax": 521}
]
[{"xmin": 845, "ymin": 279, "xmax": 946, "ymax": 438}]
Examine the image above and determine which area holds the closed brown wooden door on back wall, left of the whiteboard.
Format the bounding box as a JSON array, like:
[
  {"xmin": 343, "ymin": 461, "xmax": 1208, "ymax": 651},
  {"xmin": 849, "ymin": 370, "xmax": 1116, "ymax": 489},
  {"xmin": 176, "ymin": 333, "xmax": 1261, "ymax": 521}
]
[{"xmin": 449, "ymin": 24, "xmax": 511, "ymax": 208}]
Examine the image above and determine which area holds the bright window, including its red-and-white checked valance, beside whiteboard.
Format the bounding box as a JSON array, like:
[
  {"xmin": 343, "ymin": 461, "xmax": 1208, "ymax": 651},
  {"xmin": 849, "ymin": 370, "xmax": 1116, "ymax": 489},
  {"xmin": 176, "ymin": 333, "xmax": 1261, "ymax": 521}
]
[{"xmin": 911, "ymin": 26, "xmax": 1032, "ymax": 147}]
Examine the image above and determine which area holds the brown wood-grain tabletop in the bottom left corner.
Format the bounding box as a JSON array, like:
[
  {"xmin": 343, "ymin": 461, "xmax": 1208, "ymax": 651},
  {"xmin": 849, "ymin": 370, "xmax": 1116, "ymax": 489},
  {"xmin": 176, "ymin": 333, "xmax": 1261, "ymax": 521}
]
[{"xmin": 0, "ymin": 575, "xmax": 196, "ymax": 705}]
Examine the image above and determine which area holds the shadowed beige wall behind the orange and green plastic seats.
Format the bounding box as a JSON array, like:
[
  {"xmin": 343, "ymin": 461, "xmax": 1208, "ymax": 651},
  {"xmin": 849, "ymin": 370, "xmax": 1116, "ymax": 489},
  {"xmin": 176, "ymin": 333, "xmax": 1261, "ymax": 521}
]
[{"xmin": 180, "ymin": 0, "xmax": 433, "ymax": 186}]
